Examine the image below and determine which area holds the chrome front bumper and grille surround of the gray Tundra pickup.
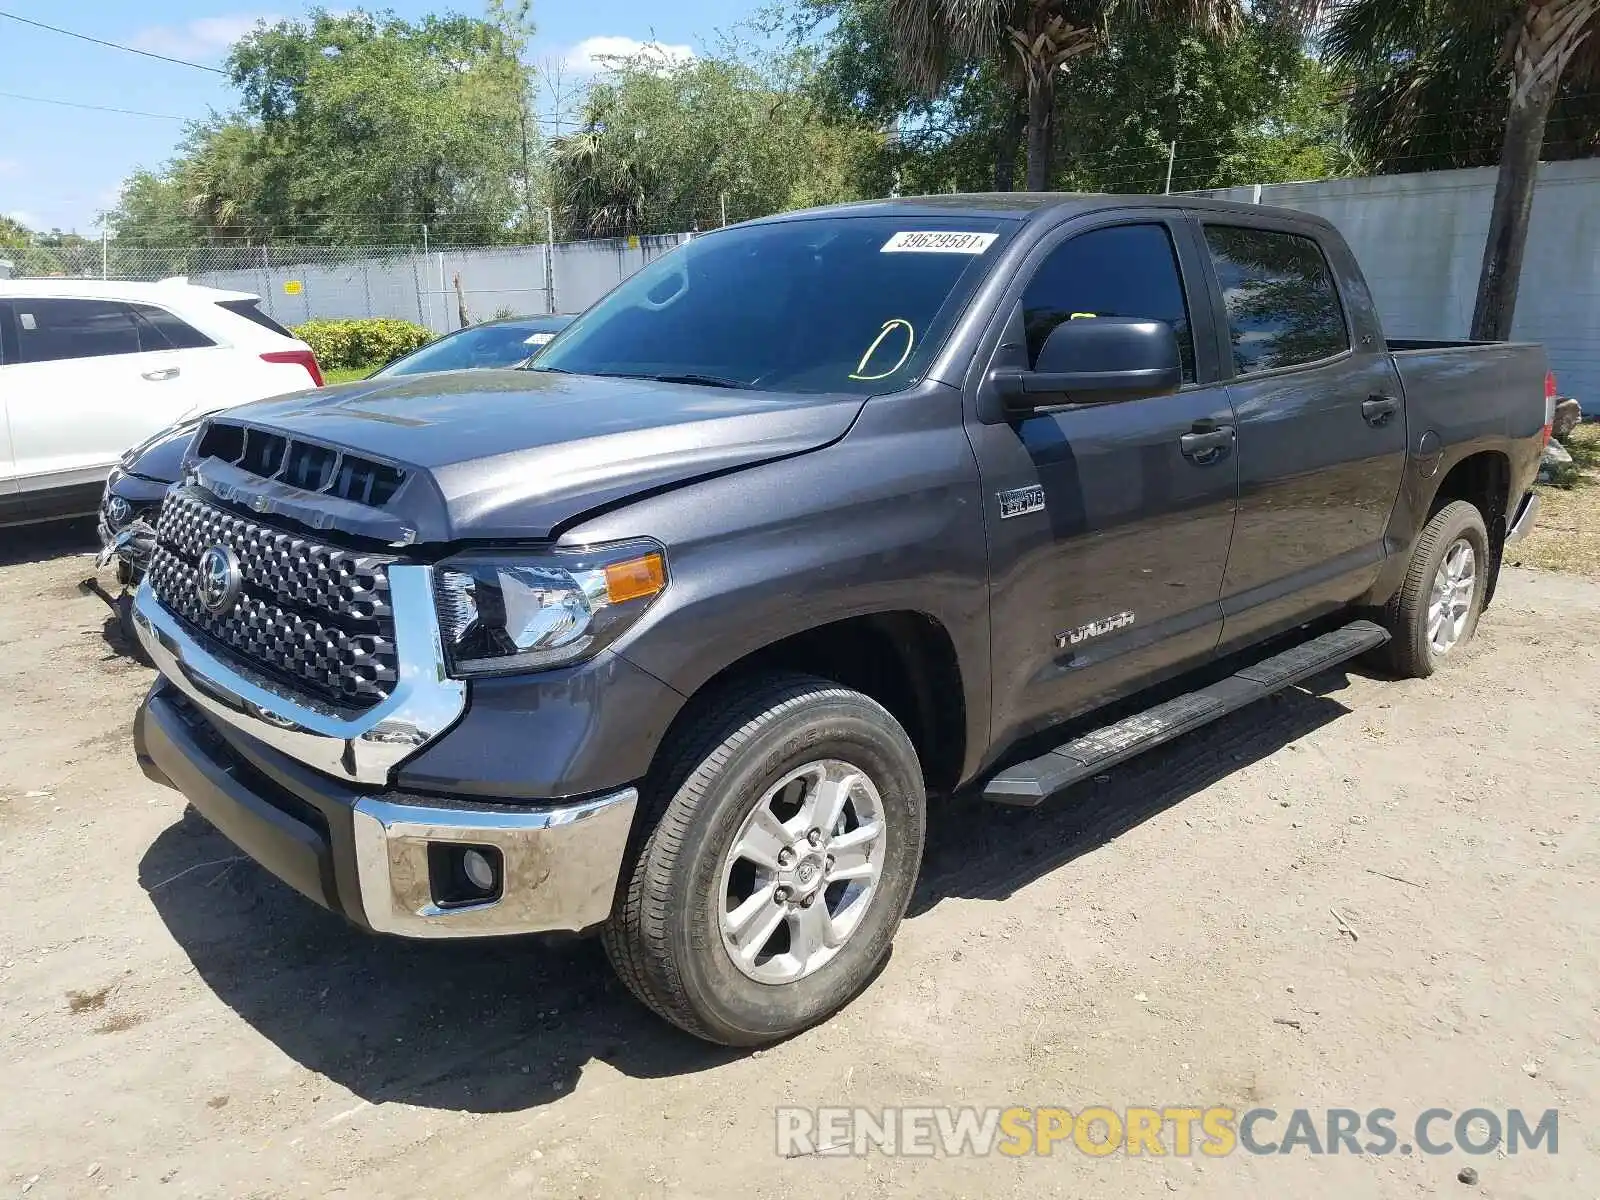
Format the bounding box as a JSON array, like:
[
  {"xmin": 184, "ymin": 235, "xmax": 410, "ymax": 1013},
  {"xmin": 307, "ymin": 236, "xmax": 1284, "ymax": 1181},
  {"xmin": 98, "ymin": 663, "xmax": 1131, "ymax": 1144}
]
[{"xmin": 134, "ymin": 582, "xmax": 638, "ymax": 938}]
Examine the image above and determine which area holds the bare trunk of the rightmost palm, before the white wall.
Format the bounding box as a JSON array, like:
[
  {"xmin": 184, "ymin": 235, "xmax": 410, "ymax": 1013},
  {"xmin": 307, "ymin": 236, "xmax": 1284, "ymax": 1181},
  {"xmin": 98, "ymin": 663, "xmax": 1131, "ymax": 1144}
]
[{"xmin": 1470, "ymin": 78, "xmax": 1555, "ymax": 341}]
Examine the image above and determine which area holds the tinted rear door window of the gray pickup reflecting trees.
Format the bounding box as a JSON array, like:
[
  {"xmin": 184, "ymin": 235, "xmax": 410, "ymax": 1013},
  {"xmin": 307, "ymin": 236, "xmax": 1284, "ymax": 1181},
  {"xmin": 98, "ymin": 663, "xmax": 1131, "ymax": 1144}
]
[{"xmin": 1205, "ymin": 226, "xmax": 1350, "ymax": 374}]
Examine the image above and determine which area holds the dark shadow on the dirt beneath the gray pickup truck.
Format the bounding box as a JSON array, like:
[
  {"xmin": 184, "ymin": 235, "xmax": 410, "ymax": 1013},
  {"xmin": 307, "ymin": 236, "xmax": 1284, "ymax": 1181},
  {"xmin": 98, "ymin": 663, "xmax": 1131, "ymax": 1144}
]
[{"xmin": 139, "ymin": 672, "xmax": 1349, "ymax": 1112}]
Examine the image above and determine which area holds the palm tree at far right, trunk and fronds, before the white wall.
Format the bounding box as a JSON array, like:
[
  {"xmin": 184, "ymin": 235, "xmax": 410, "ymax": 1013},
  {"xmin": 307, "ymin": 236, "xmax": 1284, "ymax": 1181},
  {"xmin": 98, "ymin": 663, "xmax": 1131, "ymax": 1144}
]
[{"xmin": 1323, "ymin": 0, "xmax": 1600, "ymax": 339}]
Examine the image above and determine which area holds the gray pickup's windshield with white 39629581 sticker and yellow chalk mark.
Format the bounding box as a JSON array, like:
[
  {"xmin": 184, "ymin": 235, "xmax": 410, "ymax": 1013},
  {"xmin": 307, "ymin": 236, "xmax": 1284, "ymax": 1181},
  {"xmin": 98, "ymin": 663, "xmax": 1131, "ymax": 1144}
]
[{"xmin": 531, "ymin": 214, "xmax": 1014, "ymax": 394}]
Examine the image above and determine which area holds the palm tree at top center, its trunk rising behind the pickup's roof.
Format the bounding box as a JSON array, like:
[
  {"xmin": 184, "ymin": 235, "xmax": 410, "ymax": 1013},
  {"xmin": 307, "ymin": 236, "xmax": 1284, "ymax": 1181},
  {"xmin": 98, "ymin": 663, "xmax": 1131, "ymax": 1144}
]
[{"xmin": 890, "ymin": 0, "xmax": 1245, "ymax": 192}]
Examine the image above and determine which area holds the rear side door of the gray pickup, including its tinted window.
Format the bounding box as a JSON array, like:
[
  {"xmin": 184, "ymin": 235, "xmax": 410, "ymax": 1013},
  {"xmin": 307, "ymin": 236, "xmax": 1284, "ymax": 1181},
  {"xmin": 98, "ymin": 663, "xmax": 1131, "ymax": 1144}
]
[{"xmin": 1197, "ymin": 213, "xmax": 1406, "ymax": 646}]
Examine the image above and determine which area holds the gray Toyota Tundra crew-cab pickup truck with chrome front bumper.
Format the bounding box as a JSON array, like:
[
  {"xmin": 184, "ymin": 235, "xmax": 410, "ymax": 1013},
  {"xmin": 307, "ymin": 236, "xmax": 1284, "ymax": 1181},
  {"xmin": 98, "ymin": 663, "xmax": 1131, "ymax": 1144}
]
[{"xmin": 134, "ymin": 194, "xmax": 1554, "ymax": 1045}]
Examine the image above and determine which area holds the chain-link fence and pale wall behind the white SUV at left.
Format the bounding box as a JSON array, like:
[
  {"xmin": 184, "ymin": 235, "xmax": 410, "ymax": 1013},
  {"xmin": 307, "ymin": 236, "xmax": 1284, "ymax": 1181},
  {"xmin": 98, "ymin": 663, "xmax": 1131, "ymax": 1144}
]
[{"xmin": 0, "ymin": 234, "xmax": 693, "ymax": 333}]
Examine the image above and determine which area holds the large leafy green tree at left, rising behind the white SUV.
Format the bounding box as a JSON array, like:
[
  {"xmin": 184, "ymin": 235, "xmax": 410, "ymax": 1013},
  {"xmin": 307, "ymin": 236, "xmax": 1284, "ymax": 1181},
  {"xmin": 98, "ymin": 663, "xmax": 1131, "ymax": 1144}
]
[{"xmin": 110, "ymin": 0, "xmax": 542, "ymax": 243}]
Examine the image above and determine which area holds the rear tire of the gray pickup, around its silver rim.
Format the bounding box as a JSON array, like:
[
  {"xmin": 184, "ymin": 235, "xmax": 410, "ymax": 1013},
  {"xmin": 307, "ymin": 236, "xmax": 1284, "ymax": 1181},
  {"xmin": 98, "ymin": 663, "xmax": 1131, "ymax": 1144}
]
[{"xmin": 1384, "ymin": 501, "xmax": 1490, "ymax": 678}]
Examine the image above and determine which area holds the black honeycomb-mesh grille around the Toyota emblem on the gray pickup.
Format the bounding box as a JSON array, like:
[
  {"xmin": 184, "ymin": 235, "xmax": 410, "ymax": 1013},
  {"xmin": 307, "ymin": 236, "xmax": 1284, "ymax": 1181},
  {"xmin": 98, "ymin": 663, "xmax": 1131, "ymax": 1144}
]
[{"xmin": 149, "ymin": 490, "xmax": 397, "ymax": 704}]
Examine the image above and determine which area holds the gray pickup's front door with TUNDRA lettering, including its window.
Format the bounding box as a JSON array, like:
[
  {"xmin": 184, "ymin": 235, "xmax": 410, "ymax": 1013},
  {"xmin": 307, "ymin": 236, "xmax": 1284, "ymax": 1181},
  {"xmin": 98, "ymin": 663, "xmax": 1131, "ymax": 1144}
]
[{"xmin": 968, "ymin": 211, "xmax": 1238, "ymax": 744}]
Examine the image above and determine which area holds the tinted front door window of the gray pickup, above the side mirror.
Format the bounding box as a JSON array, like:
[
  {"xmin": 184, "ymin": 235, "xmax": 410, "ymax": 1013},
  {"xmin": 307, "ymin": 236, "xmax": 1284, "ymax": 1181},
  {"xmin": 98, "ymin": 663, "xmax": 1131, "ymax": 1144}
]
[{"xmin": 1022, "ymin": 226, "xmax": 1195, "ymax": 382}]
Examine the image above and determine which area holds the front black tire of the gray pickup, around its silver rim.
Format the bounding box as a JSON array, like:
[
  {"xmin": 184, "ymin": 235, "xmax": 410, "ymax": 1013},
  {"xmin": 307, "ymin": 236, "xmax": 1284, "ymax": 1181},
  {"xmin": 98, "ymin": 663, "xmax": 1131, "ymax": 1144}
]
[{"xmin": 602, "ymin": 674, "xmax": 926, "ymax": 1045}]
